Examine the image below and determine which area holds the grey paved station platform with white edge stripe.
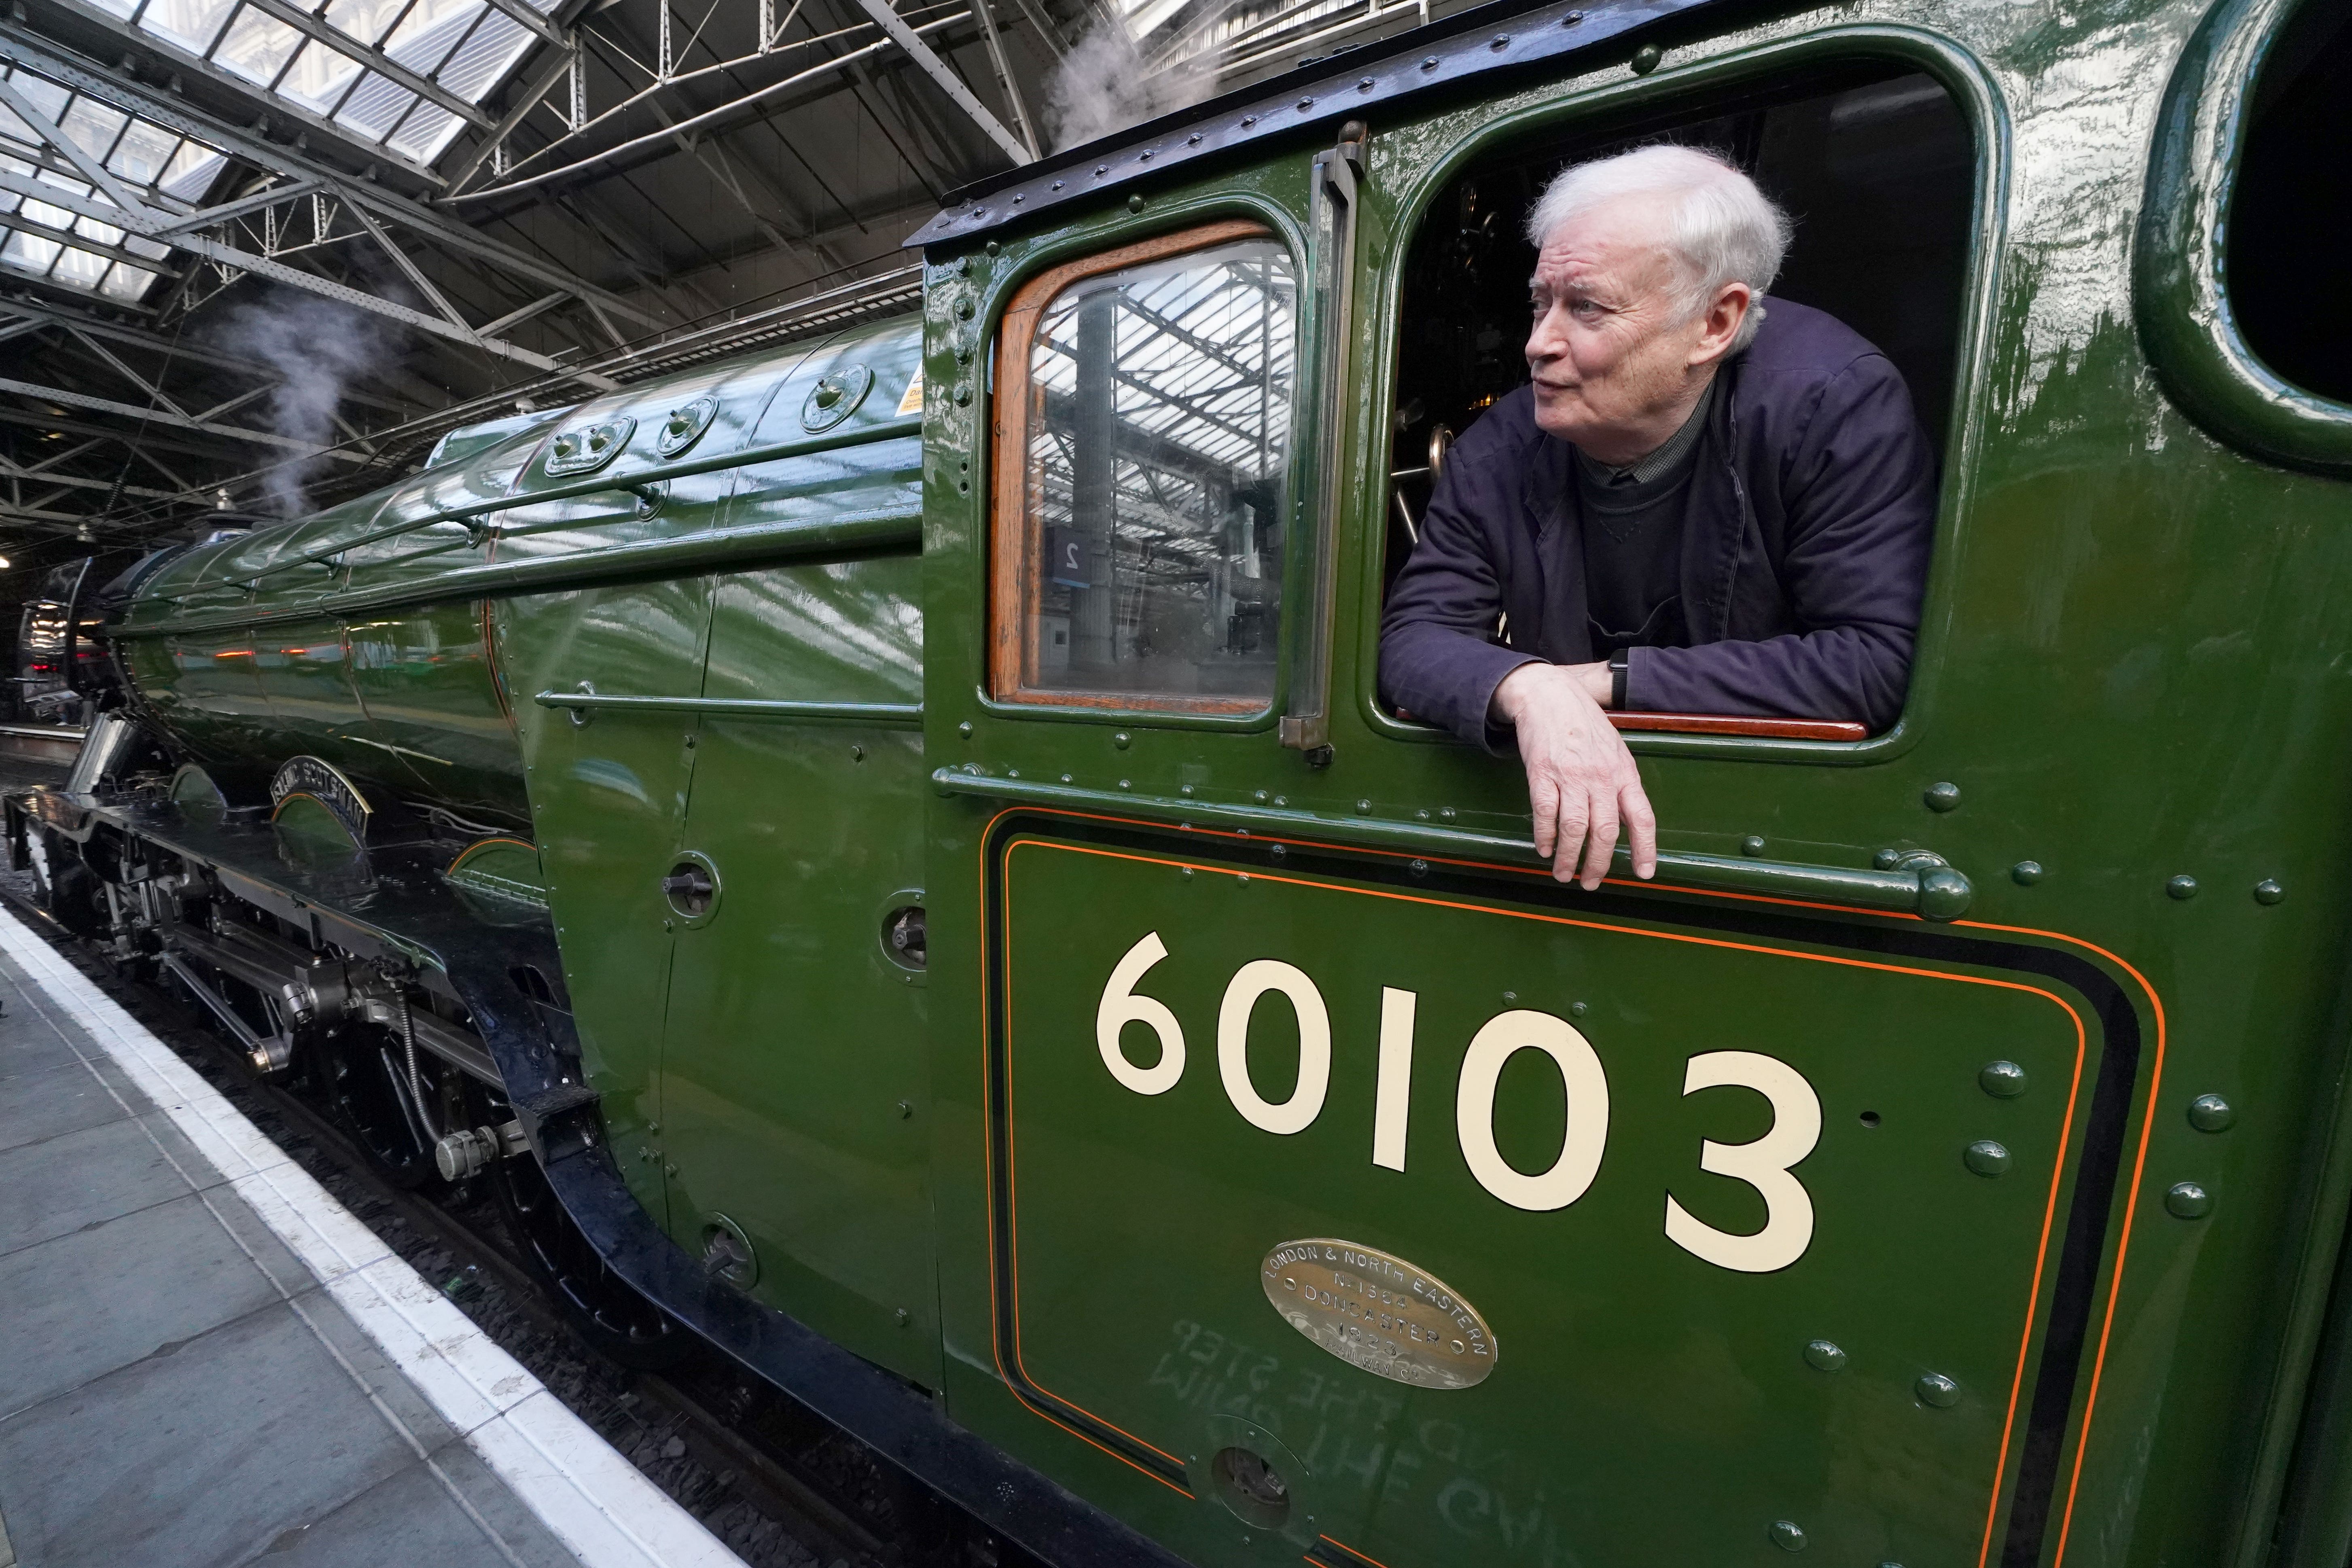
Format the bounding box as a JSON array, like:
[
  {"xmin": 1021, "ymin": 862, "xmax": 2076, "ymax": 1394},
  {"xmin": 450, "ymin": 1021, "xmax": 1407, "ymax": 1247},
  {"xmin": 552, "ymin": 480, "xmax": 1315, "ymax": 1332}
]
[{"xmin": 0, "ymin": 912, "xmax": 739, "ymax": 1568}]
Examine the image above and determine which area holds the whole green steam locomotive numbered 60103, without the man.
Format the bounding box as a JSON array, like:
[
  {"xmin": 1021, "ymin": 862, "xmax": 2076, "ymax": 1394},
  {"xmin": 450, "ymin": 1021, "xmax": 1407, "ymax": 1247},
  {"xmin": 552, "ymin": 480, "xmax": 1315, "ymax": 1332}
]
[{"xmin": 7, "ymin": 0, "xmax": 2352, "ymax": 1568}]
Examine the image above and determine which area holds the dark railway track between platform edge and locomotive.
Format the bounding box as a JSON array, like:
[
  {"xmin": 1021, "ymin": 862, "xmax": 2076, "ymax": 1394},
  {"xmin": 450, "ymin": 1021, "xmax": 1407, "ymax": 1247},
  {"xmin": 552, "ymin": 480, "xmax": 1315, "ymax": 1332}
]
[{"xmin": 0, "ymin": 872, "xmax": 1032, "ymax": 1568}]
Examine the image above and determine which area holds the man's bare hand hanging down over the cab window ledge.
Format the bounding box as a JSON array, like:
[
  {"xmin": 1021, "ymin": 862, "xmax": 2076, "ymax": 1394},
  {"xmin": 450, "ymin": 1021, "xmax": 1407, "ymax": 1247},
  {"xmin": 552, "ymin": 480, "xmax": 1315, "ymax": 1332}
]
[{"xmin": 1494, "ymin": 665, "xmax": 1658, "ymax": 893}]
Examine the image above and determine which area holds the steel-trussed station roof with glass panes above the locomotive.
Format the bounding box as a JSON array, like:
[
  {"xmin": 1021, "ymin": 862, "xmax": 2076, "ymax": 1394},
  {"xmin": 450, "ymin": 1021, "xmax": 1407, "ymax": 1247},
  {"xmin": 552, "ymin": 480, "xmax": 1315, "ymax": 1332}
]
[{"xmin": 0, "ymin": 0, "xmax": 1428, "ymax": 559}]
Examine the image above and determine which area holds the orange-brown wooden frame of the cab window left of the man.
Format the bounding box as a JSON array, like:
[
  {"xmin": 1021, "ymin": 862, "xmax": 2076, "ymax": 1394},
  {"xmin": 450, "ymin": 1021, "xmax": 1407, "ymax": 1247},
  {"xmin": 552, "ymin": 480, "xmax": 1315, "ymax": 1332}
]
[{"xmin": 988, "ymin": 218, "xmax": 1296, "ymax": 717}]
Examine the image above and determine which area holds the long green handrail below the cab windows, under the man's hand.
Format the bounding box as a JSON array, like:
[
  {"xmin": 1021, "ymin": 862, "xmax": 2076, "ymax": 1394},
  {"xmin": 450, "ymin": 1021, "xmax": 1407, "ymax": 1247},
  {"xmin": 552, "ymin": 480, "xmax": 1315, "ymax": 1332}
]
[{"xmin": 931, "ymin": 769, "xmax": 1976, "ymax": 922}]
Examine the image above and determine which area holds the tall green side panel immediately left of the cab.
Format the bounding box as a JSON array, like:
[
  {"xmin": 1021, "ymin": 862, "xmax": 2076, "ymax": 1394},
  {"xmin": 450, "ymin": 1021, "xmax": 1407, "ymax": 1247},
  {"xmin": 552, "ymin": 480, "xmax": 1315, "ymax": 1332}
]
[{"xmin": 663, "ymin": 555, "xmax": 941, "ymax": 1387}]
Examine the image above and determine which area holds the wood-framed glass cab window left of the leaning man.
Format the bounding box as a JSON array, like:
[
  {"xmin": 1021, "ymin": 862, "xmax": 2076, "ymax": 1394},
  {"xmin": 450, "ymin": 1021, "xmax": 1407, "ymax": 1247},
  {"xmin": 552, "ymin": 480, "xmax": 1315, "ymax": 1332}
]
[{"xmin": 990, "ymin": 223, "xmax": 1298, "ymax": 715}]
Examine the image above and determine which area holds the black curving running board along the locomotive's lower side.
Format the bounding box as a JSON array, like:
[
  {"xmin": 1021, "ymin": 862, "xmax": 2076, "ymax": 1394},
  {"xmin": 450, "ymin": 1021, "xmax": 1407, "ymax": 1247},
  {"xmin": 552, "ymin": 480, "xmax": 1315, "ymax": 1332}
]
[{"xmin": 5, "ymin": 788, "xmax": 1183, "ymax": 1568}]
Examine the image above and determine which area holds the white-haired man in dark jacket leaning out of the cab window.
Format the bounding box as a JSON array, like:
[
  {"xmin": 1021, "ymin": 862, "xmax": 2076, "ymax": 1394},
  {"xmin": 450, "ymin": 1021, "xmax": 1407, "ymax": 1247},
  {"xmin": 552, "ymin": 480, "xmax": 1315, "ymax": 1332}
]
[{"xmin": 1381, "ymin": 146, "xmax": 1936, "ymax": 889}]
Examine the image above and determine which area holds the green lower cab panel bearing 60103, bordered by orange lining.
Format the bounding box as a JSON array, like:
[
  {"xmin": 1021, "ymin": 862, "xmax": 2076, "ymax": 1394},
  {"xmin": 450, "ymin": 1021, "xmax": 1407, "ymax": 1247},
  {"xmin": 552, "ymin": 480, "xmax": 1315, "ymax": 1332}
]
[{"xmin": 988, "ymin": 818, "xmax": 2100, "ymax": 1563}]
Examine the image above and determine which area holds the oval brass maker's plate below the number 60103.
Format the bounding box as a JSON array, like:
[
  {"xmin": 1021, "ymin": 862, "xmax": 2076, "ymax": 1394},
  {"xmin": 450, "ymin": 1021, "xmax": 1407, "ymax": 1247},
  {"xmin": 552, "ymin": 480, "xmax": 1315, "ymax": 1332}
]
[{"xmin": 1258, "ymin": 1237, "xmax": 1496, "ymax": 1389}]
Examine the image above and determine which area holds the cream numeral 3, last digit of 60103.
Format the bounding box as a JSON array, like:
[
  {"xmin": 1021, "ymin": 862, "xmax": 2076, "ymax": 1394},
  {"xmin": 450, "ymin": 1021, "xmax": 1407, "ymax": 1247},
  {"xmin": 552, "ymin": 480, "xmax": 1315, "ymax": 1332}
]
[{"xmin": 1665, "ymin": 1051, "xmax": 1820, "ymax": 1274}]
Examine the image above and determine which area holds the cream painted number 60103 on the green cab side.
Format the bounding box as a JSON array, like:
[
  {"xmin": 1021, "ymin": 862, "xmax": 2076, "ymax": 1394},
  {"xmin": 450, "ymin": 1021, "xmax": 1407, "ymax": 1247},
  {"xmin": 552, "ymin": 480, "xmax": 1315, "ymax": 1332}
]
[{"xmin": 1094, "ymin": 931, "xmax": 1820, "ymax": 1274}]
